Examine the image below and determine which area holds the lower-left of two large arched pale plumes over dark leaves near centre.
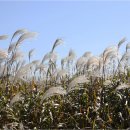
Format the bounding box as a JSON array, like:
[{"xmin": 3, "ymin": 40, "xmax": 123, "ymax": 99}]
[{"xmin": 42, "ymin": 86, "xmax": 66, "ymax": 101}]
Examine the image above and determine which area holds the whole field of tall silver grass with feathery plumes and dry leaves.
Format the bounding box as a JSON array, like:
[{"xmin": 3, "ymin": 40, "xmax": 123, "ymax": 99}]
[{"xmin": 0, "ymin": 29, "xmax": 130, "ymax": 130}]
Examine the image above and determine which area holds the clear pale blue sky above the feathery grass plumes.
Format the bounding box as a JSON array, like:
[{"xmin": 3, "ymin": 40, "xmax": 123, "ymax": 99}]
[{"xmin": 0, "ymin": 1, "xmax": 130, "ymax": 61}]
